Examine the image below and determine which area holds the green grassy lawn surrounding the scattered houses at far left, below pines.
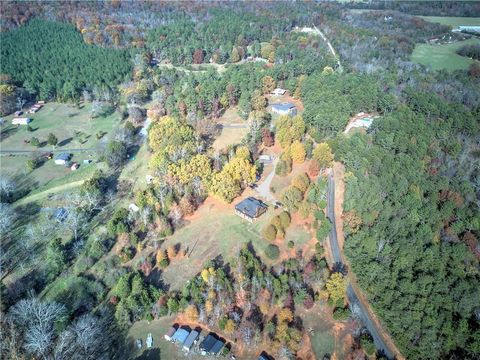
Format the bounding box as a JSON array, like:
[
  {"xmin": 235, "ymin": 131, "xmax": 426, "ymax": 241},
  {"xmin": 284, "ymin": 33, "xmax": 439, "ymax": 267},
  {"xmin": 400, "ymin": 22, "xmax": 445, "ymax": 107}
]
[{"xmin": 0, "ymin": 103, "xmax": 120, "ymax": 201}]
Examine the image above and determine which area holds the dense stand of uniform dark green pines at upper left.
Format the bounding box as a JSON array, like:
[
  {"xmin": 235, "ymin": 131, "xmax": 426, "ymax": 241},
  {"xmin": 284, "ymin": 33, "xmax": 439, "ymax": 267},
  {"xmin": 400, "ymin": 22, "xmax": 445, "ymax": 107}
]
[{"xmin": 0, "ymin": 19, "xmax": 131, "ymax": 100}]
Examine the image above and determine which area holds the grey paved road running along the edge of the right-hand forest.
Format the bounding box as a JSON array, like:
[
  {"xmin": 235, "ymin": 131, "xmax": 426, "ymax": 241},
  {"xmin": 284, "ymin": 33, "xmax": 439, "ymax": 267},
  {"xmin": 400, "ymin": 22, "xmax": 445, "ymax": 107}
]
[{"xmin": 327, "ymin": 173, "xmax": 394, "ymax": 359}]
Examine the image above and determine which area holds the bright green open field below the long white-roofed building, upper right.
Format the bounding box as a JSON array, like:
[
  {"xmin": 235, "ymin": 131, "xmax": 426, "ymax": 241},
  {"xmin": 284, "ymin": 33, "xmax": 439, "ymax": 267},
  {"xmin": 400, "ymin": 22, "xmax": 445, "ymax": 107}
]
[{"xmin": 411, "ymin": 39, "xmax": 480, "ymax": 71}]
